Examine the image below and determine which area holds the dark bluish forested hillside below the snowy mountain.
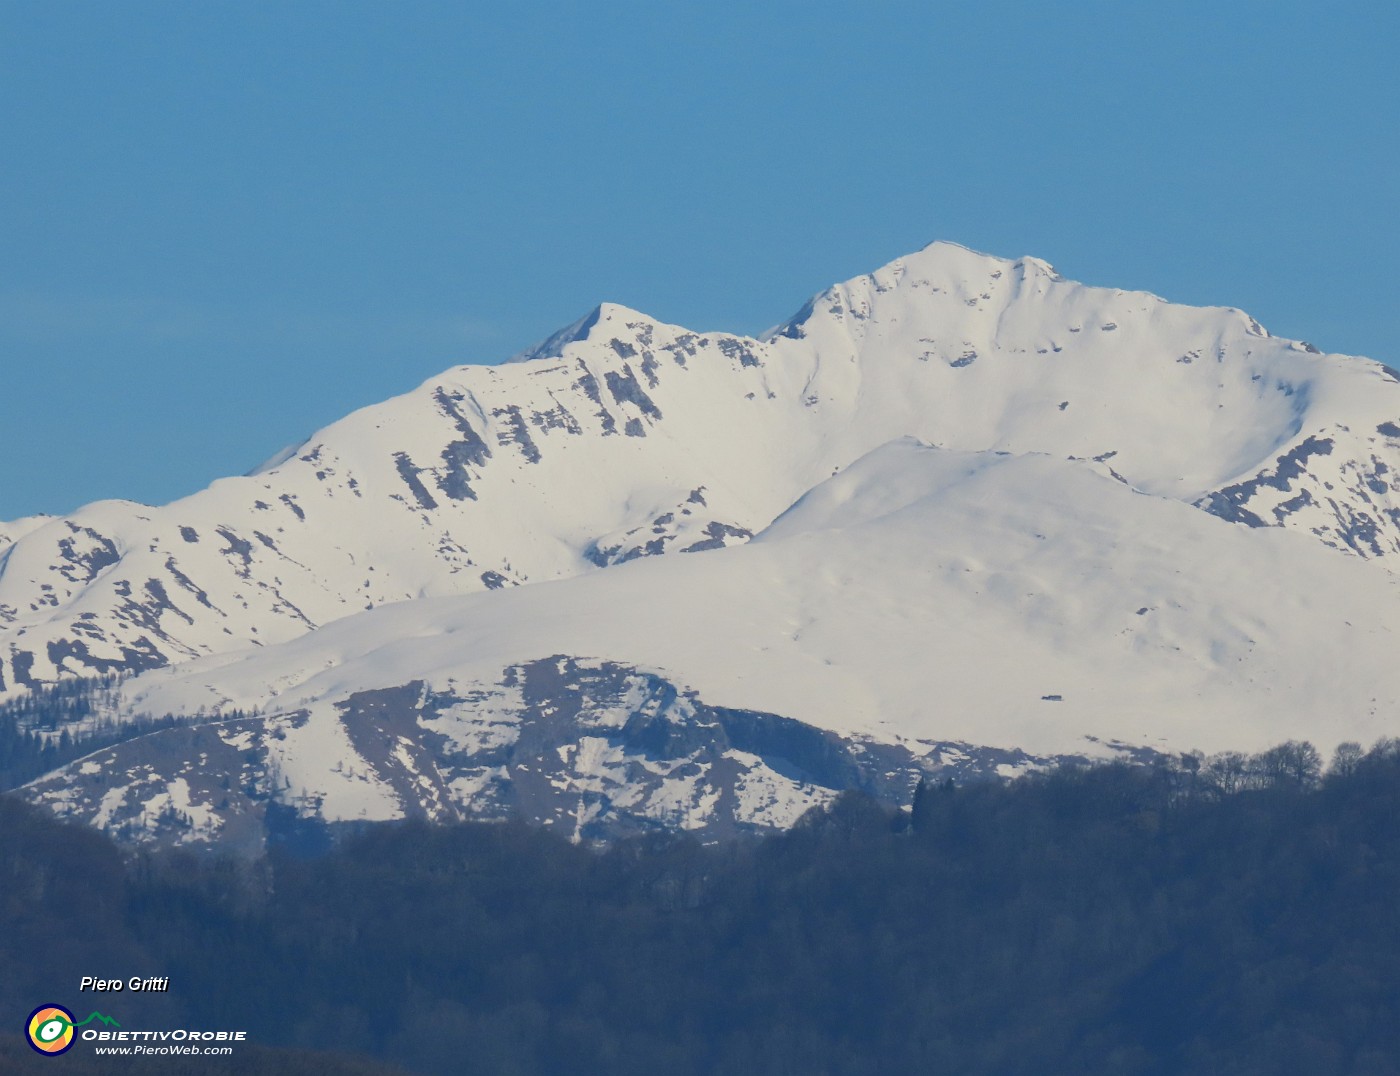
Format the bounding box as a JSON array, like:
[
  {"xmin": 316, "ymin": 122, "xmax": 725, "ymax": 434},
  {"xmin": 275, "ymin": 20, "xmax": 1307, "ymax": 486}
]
[{"xmin": 8, "ymin": 742, "xmax": 1400, "ymax": 1076}]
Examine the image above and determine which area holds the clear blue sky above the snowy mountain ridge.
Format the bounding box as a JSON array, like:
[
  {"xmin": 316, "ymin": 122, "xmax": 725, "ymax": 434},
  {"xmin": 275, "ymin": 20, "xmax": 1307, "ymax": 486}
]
[{"xmin": 0, "ymin": 0, "xmax": 1400, "ymax": 519}]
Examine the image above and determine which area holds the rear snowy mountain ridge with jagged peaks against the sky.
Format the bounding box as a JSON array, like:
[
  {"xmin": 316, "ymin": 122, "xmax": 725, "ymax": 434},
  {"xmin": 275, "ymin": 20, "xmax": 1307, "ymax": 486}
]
[{"xmin": 0, "ymin": 243, "xmax": 1400, "ymax": 694}]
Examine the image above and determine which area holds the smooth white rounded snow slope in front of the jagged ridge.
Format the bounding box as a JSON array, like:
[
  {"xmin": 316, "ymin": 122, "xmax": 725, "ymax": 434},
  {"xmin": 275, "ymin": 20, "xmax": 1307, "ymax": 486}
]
[{"xmin": 106, "ymin": 439, "xmax": 1400, "ymax": 753}]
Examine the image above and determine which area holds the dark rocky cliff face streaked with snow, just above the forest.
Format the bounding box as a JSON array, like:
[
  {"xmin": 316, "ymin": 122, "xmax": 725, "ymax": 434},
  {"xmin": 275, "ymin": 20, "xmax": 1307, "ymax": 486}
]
[{"xmin": 25, "ymin": 656, "xmax": 1064, "ymax": 851}]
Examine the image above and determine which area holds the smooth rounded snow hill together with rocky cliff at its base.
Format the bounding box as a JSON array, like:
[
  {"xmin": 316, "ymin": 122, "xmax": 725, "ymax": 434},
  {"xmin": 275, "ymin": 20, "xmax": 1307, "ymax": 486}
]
[{"xmin": 19, "ymin": 439, "xmax": 1400, "ymax": 841}]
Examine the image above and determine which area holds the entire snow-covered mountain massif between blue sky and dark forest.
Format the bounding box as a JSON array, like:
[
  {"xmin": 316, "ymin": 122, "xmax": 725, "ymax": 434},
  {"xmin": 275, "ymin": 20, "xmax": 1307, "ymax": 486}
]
[{"xmin": 8, "ymin": 243, "xmax": 1400, "ymax": 840}]
